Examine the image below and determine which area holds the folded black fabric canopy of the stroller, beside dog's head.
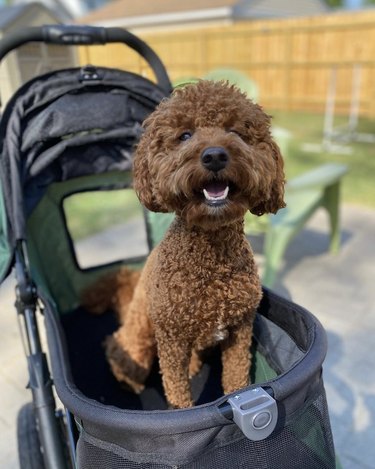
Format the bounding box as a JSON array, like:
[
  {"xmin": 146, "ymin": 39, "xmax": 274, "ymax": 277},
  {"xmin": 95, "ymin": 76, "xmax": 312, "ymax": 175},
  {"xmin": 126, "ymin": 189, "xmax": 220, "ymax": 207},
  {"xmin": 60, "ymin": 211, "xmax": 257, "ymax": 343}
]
[{"xmin": 0, "ymin": 66, "xmax": 170, "ymax": 280}]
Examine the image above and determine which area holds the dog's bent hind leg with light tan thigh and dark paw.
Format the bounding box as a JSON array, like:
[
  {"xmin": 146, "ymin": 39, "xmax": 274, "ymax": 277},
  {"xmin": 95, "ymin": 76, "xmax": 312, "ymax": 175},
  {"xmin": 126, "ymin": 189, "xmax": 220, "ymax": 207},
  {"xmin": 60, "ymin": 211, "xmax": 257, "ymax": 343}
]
[{"xmin": 105, "ymin": 286, "xmax": 156, "ymax": 393}]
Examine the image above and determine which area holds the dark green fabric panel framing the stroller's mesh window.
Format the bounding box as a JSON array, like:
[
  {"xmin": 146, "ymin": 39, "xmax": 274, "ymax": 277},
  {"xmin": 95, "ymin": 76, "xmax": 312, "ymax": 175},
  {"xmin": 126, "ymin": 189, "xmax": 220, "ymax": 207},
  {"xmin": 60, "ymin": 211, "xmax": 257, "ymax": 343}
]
[{"xmin": 27, "ymin": 172, "xmax": 131, "ymax": 314}]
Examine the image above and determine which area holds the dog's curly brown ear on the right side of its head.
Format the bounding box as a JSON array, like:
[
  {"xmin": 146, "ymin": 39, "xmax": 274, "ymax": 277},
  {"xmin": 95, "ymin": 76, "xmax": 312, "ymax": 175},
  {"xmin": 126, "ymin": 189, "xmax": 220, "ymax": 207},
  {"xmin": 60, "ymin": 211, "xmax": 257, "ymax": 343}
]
[{"xmin": 250, "ymin": 140, "xmax": 286, "ymax": 216}]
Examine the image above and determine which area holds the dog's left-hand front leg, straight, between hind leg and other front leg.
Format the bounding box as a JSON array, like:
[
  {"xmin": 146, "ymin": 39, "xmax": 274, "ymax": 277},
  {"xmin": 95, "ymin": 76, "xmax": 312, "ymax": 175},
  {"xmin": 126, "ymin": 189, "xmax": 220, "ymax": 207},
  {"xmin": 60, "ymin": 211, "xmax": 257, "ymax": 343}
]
[{"xmin": 158, "ymin": 337, "xmax": 194, "ymax": 408}]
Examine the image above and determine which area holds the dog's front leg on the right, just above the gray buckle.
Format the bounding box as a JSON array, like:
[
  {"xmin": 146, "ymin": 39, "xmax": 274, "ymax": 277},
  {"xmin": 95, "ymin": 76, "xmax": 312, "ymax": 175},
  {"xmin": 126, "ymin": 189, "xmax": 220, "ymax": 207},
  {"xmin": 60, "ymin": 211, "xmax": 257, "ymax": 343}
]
[{"xmin": 222, "ymin": 323, "xmax": 253, "ymax": 394}]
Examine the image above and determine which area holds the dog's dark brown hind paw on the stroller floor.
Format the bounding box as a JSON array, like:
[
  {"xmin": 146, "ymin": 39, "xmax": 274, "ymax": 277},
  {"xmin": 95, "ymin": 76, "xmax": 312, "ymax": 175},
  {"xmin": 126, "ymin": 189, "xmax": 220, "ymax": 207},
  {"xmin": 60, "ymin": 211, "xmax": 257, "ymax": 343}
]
[{"xmin": 104, "ymin": 335, "xmax": 149, "ymax": 394}]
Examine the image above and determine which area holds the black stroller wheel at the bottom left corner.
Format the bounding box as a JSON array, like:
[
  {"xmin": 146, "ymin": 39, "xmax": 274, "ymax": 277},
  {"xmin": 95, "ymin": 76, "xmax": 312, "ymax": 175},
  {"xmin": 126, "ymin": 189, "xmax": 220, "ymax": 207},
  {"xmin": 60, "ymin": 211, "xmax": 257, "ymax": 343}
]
[{"xmin": 17, "ymin": 402, "xmax": 45, "ymax": 469}]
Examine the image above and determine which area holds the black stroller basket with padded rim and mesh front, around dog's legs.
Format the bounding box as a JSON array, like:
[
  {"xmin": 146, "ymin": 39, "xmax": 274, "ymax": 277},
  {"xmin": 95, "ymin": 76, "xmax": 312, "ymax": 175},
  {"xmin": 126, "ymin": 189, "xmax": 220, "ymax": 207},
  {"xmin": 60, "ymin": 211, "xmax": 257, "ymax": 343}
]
[{"xmin": 46, "ymin": 290, "xmax": 335, "ymax": 469}]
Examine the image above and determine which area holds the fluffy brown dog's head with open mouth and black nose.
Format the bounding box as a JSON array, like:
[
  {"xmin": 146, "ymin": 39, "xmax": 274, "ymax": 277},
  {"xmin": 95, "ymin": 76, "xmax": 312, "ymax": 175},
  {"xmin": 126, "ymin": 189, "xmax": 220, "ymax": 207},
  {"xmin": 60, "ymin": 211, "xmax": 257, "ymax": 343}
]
[{"xmin": 133, "ymin": 81, "xmax": 285, "ymax": 228}]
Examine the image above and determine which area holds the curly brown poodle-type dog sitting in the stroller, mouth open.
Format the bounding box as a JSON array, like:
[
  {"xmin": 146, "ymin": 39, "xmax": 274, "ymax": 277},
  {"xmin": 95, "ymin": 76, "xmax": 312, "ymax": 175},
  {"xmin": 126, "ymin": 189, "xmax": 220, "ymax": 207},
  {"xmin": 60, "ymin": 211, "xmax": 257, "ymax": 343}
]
[{"xmin": 84, "ymin": 80, "xmax": 285, "ymax": 408}]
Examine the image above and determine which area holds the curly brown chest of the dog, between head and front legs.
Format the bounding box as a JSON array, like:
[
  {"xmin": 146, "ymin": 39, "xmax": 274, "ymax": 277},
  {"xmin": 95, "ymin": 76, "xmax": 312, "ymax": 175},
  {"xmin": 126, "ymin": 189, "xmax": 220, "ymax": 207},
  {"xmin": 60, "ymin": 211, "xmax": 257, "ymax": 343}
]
[{"xmin": 152, "ymin": 225, "xmax": 260, "ymax": 338}]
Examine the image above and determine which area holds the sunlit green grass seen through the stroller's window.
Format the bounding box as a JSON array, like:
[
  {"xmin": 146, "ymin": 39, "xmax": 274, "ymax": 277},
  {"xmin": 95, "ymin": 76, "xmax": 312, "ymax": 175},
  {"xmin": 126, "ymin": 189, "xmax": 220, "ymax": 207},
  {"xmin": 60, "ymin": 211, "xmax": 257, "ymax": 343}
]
[{"xmin": 64, "ymin": 190, "xmax": 142, "ymax": 241}]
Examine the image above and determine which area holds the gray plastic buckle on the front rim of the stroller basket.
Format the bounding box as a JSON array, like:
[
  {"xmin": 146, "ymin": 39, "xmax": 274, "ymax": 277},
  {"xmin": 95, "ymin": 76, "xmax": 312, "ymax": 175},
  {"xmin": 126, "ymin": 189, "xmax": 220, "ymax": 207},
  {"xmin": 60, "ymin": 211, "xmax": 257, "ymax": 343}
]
[{"xmin": 228, "ymin": 387, "xmax": 278, "ymax": 441}]
